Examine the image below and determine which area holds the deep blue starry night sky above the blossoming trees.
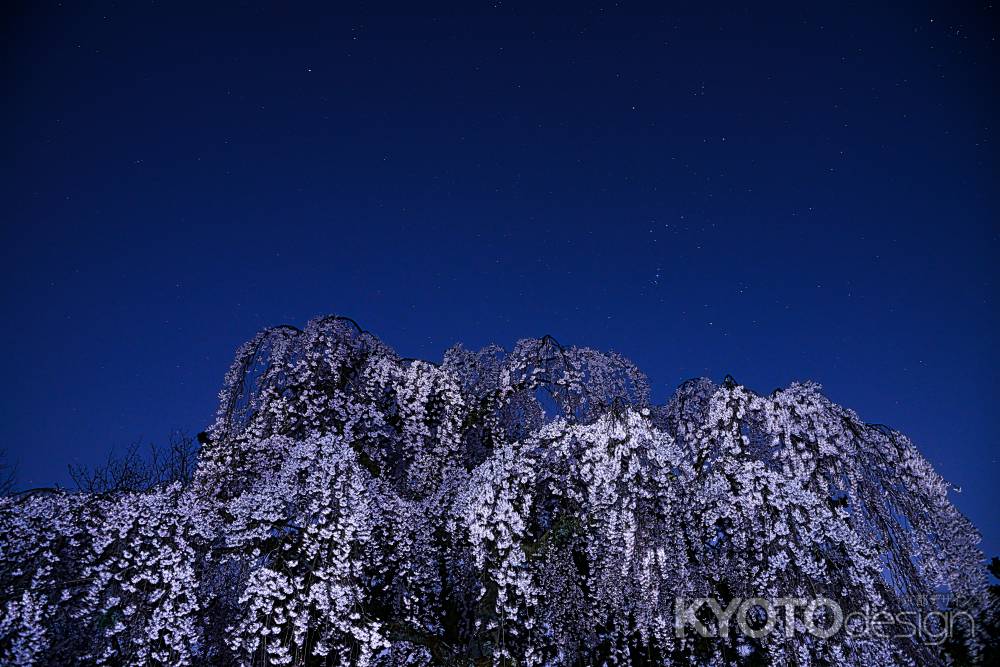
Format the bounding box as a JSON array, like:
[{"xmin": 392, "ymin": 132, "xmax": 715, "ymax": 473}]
[{"xmin": 0, "ymin": 2, "xmax": 1000, "ymax": 554}]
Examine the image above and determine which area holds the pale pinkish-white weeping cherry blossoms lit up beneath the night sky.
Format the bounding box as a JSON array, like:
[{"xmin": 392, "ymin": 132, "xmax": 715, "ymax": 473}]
[{"xmin": 0, "ymin": 317, "xmax": 987, "ymax": 666}]
